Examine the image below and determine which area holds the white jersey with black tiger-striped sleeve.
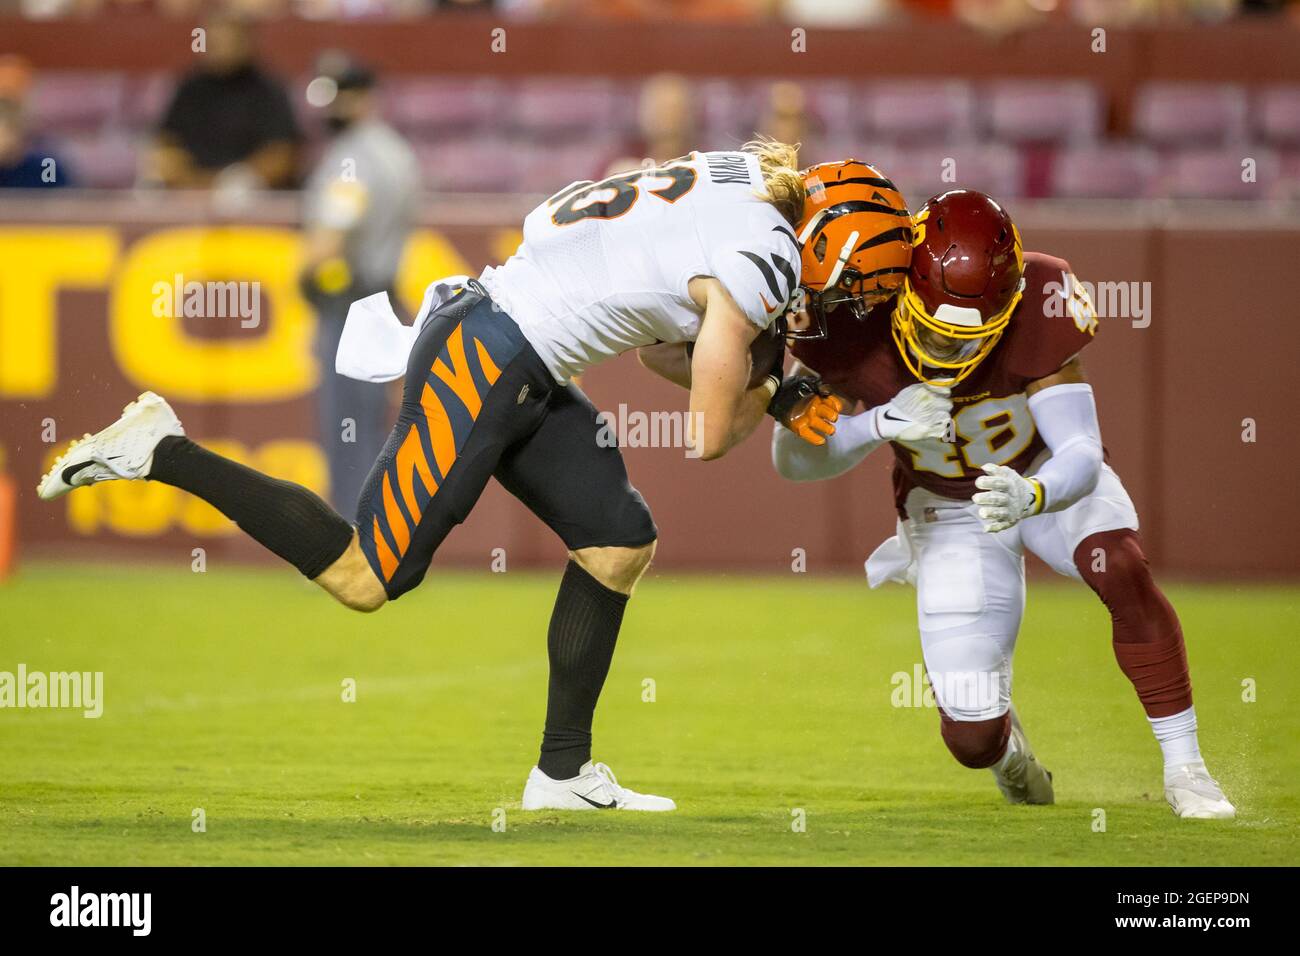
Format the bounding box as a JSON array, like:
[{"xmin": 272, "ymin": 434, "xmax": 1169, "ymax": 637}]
[{"xmin": 480, "ymin": 152, "xmax": 800, "ymax": 382}]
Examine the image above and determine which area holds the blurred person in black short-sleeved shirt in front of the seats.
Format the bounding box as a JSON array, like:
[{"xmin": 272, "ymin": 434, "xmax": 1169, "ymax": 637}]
[{"xmin": 147, "ymin": 14, "xmax": 300, "ymax": 189}]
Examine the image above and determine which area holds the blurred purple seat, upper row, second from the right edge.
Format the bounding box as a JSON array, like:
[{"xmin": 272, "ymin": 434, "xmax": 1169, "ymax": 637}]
[{"xmin": 1134, "ymin": 83, "xmax": 1247, "ymax": 147}]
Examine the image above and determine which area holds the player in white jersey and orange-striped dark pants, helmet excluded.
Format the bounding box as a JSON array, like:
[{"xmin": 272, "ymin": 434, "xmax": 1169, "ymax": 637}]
[{"xmin": 38, "ymin": 140, "xmax": 894, "ymax": 810}]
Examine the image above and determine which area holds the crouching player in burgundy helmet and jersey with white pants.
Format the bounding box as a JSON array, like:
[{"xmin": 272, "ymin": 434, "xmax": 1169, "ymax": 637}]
[{"xmin": 772, "ymin": 190, "xmax": 1235, "ymax": 818}]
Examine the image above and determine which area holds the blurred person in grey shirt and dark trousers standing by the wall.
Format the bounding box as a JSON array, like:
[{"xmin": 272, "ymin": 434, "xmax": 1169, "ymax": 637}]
[{"xmin": 300, "ymin": 53, "xmax": 420, "ymax": 509}]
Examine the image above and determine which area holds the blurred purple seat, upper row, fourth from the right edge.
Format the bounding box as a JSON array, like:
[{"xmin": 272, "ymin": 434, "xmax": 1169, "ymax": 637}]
[{"xmin": 857, "ymin": 79, "xmax": 975, "ymax": 143}]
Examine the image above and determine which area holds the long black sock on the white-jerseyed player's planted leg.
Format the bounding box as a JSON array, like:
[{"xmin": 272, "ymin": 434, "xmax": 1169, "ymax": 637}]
[{"xmin": 537, "ymin": 561, "xmax": 628, "ymax": 780}]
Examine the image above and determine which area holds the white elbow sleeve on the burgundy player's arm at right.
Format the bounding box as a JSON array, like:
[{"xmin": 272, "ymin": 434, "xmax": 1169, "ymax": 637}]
[{"xmin": 1028, "ymin": 382, "xmax": 1105, "ymax": 511}]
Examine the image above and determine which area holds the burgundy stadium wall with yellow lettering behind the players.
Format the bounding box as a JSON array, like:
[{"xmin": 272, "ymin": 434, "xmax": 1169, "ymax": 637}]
[{"xmin": 0, "ymin": 195, "xmax": 1300, "ymax": 578}]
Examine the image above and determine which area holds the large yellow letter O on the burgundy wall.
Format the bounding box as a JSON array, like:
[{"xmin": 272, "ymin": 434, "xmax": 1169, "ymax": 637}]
[{"xmin": 109, "ymin": 226, "xmax": 317, "ymax": 402}]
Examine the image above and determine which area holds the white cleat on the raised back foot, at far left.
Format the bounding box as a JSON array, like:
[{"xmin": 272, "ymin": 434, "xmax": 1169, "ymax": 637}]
[{"xmin": 36, "ymin": 392, "xmax": 185, "ymax": 501}]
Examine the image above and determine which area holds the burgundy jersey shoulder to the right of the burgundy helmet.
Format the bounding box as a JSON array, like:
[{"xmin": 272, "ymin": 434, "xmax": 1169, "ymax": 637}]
[{"xmin": 997, "ymin": 252, "xmax": 1097, "ymax": 381}]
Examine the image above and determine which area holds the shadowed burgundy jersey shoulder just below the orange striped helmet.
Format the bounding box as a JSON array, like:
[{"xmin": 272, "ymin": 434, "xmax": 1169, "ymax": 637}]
[{"xmin": 790, "ymin": 302, "xmax": 915, "ymax": 408}]
